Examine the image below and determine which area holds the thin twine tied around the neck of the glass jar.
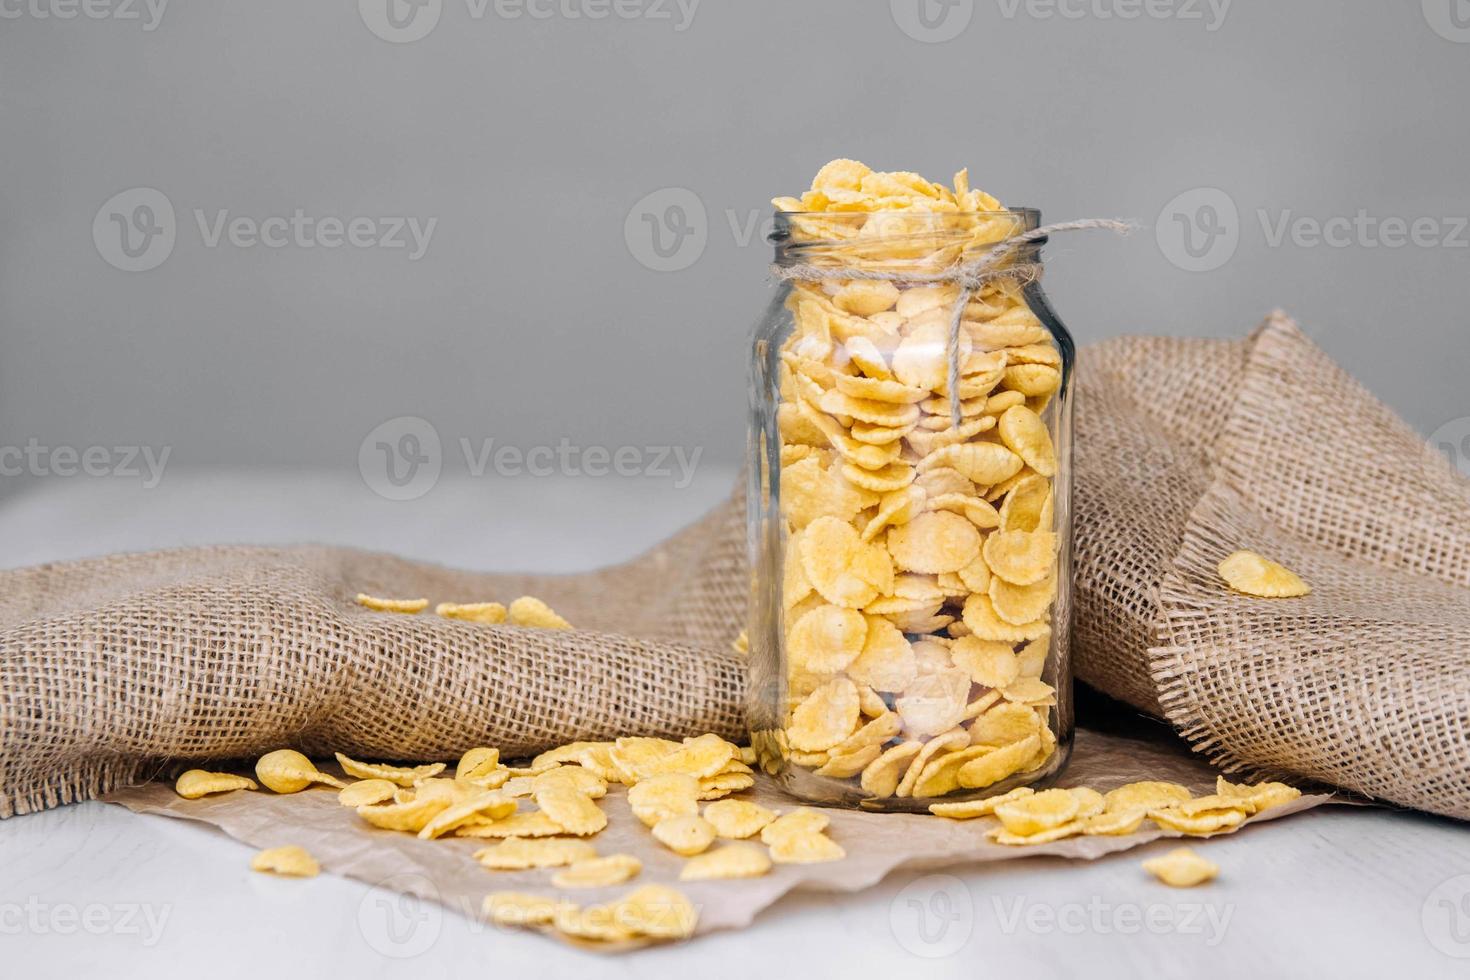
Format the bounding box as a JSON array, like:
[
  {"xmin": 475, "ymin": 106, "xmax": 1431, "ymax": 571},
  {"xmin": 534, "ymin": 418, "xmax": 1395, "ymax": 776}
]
[{"xmin": 770, "ymin": 217, "xmax": 1135, "ymax": 426}]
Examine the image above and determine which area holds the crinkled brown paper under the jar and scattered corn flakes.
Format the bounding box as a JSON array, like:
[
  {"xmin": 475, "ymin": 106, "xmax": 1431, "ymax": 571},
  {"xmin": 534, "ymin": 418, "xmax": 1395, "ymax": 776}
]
[{"xmin": 104, "ymin": 730, "xmax": 1330, "ymax": 952}]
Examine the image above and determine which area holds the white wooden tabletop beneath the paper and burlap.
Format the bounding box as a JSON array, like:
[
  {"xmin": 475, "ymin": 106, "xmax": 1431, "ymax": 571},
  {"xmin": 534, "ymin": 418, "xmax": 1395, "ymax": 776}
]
[{"xmin": 0, "ymin": 470, "xmax": 1470, "ymax": 980}]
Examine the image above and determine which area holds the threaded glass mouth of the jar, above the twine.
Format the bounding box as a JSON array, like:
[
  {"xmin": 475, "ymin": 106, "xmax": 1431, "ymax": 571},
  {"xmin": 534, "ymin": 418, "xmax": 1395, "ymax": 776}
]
[{"xmin": 766, "ymin": 207, "xmax": 1045, "ymax": 272}]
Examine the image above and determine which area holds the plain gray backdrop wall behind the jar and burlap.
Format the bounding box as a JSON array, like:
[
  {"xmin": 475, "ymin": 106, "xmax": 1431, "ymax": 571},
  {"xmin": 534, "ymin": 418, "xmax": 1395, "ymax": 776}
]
[{"xmin": 0, "ymin": 0, "xmax": 1470, "ymax": 488}]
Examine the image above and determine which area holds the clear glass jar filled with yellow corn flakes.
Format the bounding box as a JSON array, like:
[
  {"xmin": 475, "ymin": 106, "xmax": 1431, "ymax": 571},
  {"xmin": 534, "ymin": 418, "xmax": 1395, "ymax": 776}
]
[{"xmin": 748, "ymin": 209, "xmax": 1075, "ymax": 811}]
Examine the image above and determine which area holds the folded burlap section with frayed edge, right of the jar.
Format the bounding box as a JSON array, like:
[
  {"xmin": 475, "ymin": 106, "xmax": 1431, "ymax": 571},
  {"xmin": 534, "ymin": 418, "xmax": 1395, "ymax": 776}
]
[{"xmin": 1073, "ymin": 313, "xmax": 1470, "ymax": 820}]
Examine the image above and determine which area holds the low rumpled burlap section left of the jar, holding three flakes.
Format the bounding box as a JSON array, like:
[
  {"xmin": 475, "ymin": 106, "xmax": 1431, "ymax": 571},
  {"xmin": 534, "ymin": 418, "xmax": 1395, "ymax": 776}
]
[{"xmin": 0, "ymin": 498, "xmax": 748, "ymax": 815}]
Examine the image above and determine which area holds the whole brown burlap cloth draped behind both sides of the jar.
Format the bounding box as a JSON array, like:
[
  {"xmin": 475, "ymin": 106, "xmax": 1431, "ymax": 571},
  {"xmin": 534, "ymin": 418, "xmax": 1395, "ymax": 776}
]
[{"xmin": 0, "ymin": 316, "xmax": 1470, "ymax": 818}]
